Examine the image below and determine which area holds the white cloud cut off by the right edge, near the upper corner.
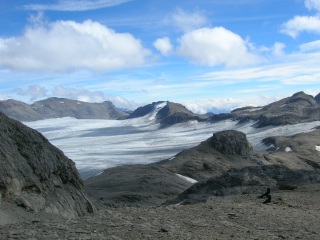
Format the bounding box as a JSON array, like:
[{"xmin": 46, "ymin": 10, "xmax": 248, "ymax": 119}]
[{"xmin": 280, "ymin": 16, "xmax": 320, "ymax": 38}]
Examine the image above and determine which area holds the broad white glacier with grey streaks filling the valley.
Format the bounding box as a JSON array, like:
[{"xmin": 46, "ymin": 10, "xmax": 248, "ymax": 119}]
[{"xmin": 24, "ymin": 115, "xmax": 320, "ymax": 178}]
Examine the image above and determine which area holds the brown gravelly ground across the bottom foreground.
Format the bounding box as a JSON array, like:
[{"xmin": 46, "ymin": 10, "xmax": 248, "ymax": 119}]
[{"xmin": 0, "ymin": 184, "xmax": 320, "ymax": 240}]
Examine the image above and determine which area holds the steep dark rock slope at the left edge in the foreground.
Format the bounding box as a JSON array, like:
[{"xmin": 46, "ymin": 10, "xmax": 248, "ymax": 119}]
[{"xmin": 0, "ymin": 113, "xmax": 94, "ymax": 217}]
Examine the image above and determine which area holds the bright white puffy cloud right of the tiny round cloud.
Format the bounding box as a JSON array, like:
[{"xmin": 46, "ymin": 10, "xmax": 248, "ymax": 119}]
[{"xmin": 178, "ymin": 27, "xmax": 262, "ymax": 66}]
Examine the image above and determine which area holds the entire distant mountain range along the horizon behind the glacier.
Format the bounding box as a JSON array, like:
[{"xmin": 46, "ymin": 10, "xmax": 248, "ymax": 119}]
[{"xmin": 0, "ymin": 92, "xmax": 320, "ymax": 127}]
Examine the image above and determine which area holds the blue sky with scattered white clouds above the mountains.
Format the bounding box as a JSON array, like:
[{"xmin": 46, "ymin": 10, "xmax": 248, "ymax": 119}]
[{"xmin": 0, "ymin": 0, "xmax": 320, "ymax": 113}]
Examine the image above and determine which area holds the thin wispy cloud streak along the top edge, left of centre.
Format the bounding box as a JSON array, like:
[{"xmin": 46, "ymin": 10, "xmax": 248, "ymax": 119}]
[{"xmin": 25, "ymin": 0, "xmax": 131, "ymax": 11}]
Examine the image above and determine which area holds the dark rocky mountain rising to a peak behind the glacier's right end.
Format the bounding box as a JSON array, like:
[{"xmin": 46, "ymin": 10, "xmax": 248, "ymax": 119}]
[{"xmin": 210, "ymin": 92, "xmax": 320, "ymax": 127}]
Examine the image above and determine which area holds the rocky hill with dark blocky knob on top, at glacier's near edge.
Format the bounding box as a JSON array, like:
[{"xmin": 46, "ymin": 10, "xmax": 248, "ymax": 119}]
[{"xmin": 157, "ymin": 130, "xmax": 260, "ymax": 181}]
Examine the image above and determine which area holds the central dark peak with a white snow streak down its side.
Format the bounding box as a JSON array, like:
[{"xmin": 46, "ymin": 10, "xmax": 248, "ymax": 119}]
[{"xmin": 128, "ymin": 101, "xmax": 207, "ymax": 127}]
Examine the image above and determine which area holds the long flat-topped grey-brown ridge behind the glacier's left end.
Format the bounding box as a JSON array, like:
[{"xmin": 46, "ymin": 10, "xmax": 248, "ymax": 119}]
[{"xmin": 0, "ymin": 97, "xmax": 128, "ymax": 121}]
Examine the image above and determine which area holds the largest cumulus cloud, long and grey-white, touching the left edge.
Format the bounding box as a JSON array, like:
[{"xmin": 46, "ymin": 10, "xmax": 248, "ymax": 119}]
[{"xmin": 0, "ymin": 20, "xmax": 150, "ymax": 71}]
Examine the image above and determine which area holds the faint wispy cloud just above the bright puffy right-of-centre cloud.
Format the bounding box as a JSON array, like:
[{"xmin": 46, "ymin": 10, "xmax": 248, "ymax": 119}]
[{"xmin": 166, "ymin": 9, "xmax": 208, "ymax": 32}]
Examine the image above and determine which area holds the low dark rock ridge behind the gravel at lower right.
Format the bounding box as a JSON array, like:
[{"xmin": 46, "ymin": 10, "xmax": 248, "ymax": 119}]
[{"xmin": 167, "ymin": 165, "xmax": 320, "ymax": 204}]
